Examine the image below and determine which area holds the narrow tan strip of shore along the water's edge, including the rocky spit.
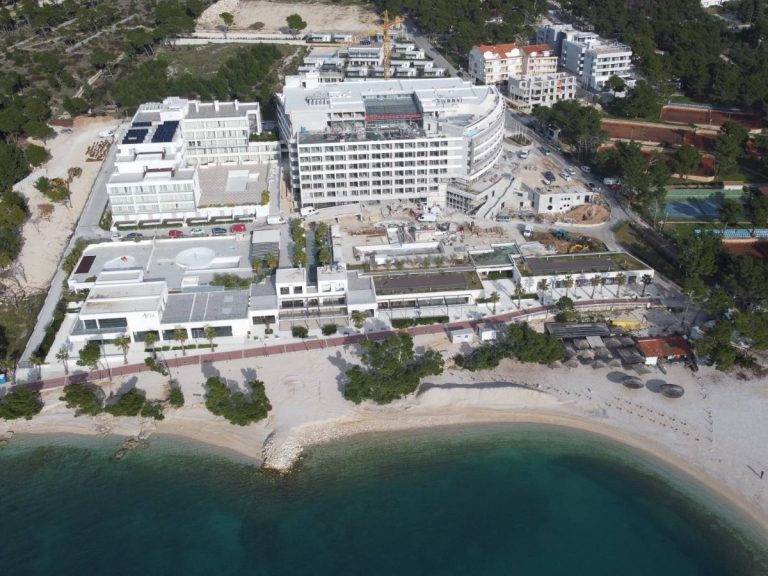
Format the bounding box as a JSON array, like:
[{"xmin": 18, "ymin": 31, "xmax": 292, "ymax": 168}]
[{"xmin": 7, "ymin": 392, "xmax": 768, "ymax": 543}]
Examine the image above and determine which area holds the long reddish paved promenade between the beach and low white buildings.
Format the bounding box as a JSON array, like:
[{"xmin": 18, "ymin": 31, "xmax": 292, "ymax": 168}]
[{"xmin": 28, "ymin": 297, "xmax": 661, "ymax": 390}]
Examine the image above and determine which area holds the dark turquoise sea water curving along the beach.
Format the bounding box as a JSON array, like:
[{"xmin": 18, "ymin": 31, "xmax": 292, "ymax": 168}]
[{"xmin": 0, "ymin": 425, "xmax": 768, "ymax": 576}]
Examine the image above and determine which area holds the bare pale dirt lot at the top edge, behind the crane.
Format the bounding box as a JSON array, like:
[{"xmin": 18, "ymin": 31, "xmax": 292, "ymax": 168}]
[{"xmin": 197, "ymin": 0, "xmax": 379, "ymax": 33}]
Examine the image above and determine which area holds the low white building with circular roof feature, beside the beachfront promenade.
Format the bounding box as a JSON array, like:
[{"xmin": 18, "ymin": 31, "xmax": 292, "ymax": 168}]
[{"xmin": 61, "ymin": 235, "xmax": 253, "ymax": 352}]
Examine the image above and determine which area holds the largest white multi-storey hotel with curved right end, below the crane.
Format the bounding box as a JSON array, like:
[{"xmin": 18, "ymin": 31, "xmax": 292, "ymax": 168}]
[{"xmin": 277, "ymin": 77, "xmax": 504, "ymax": 206}]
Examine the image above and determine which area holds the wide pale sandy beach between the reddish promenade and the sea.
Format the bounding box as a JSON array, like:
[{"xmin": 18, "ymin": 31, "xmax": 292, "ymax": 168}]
[{"xmin": 6, "ymin": 336, "xmax": 768, "ymax": 531}]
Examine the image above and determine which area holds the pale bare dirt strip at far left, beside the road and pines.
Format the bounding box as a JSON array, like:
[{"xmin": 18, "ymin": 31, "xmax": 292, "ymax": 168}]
[{"xmin": 9, "ymin": 117, "xmax": 119, "ymax": 290}]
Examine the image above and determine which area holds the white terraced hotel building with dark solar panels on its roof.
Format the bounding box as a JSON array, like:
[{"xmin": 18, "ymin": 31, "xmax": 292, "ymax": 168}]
[{"xmin": 107, "ymin": 98, "xmax": 280, "ymax": 224}]
